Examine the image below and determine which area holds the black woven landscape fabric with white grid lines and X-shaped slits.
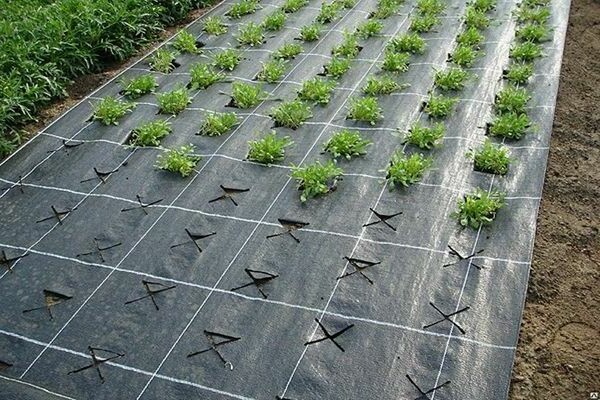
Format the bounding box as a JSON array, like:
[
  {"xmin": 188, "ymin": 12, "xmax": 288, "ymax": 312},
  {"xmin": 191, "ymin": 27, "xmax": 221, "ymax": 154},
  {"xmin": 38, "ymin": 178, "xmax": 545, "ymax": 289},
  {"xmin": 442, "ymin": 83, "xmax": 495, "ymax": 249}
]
[{"xmin": 0, "ymin": 0, "xmax": 569, "ymax": 400}]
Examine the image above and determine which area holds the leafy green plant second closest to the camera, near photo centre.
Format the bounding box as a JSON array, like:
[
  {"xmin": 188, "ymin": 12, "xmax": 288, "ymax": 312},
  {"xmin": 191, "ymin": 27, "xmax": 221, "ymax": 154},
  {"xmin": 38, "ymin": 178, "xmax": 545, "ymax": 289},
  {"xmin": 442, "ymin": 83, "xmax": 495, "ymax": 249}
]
[{"xmin": 291, "ymin": 161, "xmax": 344, "ymax": 202}]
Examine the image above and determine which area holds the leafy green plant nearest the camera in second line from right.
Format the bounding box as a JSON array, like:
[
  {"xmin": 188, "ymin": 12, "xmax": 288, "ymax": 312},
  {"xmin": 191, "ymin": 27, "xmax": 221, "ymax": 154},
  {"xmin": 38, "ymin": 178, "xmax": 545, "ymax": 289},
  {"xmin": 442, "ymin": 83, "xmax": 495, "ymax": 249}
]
[{"xmin": 385, "ymin": 150, "xmax": 433, "ymax": 190}]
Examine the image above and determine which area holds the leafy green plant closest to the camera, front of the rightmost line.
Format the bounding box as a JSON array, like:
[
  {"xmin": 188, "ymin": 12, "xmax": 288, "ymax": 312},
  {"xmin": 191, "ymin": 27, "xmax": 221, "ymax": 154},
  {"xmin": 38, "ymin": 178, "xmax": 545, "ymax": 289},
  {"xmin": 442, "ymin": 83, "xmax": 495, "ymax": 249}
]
[{"xmin": 451, "ymin": 188, "xmax": 505, "ymax": 229}]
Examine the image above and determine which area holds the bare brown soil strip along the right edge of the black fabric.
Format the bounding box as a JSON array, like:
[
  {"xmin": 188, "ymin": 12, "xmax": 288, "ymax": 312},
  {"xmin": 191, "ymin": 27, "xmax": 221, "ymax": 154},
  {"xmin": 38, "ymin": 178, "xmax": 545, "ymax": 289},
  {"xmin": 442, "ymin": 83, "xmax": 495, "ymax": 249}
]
[{"xmin": 510, "ymin": 0, "xmax": 600, "ymax": 400}]
